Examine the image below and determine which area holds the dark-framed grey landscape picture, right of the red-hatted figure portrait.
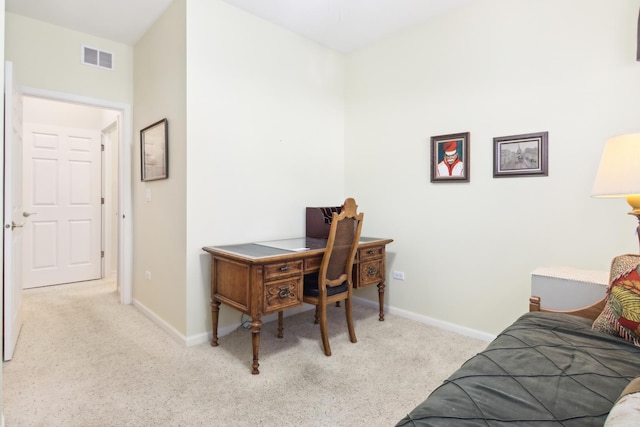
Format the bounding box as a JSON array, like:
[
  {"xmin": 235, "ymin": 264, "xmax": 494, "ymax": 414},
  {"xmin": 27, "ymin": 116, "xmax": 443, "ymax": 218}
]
[{"xmin": 493, "ymin": 132, "xmax": 549, "ymax": 178}]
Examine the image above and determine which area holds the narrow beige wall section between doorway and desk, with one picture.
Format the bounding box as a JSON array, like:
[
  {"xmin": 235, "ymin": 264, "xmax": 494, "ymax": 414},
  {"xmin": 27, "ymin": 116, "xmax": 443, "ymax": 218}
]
[{"xmin": 132, "ymin": 0, "xmax": 187, "ymax": 335}]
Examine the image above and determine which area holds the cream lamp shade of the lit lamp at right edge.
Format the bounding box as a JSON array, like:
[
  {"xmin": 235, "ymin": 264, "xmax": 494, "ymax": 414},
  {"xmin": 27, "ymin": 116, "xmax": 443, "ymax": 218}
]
[{"xmin": 591, "ymin": 133, "xmax": 640, "ymax": 197}]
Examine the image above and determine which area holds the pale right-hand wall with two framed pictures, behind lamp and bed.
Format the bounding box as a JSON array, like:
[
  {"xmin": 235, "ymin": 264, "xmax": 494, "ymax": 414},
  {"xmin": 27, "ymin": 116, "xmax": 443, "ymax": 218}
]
[{"xmin": 345, "ymin": 0, "xmax": 640, "ymax": 333}]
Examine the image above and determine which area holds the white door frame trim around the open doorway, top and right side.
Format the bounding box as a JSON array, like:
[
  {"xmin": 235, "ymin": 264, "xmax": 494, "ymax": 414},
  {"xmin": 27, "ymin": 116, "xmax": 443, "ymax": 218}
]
[{"xmin": 21, "ymin": 86, "xmax": 133, "ymax": 304}]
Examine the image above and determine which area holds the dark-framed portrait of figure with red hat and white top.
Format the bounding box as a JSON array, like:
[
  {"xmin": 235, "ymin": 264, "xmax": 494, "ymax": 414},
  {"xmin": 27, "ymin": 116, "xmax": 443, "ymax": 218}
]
[{"xmin": 431, "ymin": 132, "xmax": 471, "ymax": 183}]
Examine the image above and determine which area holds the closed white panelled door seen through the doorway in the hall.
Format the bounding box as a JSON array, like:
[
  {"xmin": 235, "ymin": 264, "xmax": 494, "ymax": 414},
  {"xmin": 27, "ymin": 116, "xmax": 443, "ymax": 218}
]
[{"xmin": 23, "ymin": 123, "xmax": 102, "ymax": 288}]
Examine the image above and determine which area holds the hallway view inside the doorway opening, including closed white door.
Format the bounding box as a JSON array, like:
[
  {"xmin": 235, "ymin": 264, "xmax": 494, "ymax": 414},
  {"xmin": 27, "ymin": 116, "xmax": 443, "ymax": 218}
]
[{"xmin": 22, "ymin": 96, "xmax": 114, "ymax": 289}]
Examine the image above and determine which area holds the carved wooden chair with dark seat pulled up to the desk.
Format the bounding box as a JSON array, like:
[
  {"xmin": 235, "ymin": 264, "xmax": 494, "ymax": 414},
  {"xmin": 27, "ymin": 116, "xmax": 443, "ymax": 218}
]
[{"xmin": 302, "ymin": 198, "xmax": 364, "ymax": 356}]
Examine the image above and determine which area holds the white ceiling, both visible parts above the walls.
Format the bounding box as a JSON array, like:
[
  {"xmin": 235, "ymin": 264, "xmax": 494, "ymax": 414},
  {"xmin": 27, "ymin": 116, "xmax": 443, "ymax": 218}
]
[{"xmin": 5, "ymin": 0, "xmax": 473, "ymax": 52}]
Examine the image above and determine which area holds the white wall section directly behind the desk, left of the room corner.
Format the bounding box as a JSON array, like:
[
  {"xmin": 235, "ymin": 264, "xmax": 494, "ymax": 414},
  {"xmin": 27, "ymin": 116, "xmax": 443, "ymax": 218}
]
[{"xmin": 186, "ymin": 0, "xmax": 344, "ymax": 334}]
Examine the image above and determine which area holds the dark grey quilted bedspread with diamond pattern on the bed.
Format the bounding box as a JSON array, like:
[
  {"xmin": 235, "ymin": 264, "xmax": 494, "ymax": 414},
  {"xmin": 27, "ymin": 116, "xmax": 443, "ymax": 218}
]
[{"xmin": 397, "ymin": 313, "xmax": 640, "ymax": 427}]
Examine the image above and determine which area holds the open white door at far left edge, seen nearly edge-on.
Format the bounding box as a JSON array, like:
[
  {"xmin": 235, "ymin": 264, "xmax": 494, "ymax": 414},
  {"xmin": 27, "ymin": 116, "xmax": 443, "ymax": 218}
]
[{"xmin": 2, "ymin": 62, "xmax": 27, "ymax": 360}]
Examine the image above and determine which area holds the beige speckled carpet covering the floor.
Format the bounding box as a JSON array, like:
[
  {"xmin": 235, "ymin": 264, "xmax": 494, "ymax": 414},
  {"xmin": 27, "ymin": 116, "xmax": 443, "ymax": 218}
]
[{"xmin": 3, "ymin": 281, "xmax": 486, "ymax": 427}]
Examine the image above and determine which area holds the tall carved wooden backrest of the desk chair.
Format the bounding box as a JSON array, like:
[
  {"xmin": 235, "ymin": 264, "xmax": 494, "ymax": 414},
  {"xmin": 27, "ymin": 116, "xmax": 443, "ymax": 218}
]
[{"xmin": 318, "ymin": 198, "xmax": 364, "ymax": 288}]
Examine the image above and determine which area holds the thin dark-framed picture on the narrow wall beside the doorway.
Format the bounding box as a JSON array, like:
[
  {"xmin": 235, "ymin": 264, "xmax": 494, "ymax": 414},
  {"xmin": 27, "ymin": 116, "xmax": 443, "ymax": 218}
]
[{"xmin": 140, "ymin": 119, "xmax": 169, "ymax": 181}]
